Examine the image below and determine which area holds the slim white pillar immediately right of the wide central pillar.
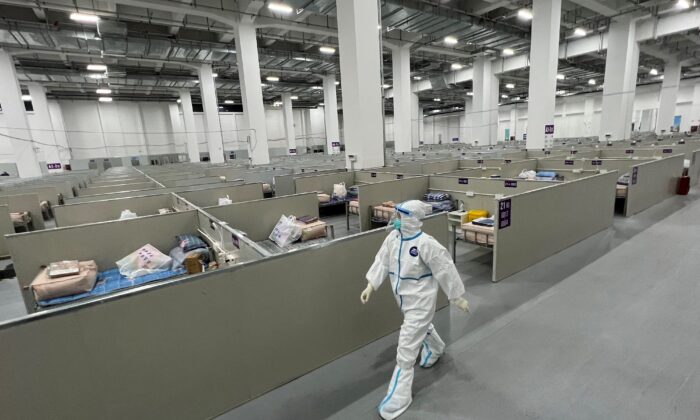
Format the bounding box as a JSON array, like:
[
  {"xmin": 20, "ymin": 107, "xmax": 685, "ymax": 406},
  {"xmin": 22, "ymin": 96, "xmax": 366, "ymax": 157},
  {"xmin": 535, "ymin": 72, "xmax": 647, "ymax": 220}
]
[{"xmin": 391, "ymin": 44, "xmax": 413, "ymax": 153}]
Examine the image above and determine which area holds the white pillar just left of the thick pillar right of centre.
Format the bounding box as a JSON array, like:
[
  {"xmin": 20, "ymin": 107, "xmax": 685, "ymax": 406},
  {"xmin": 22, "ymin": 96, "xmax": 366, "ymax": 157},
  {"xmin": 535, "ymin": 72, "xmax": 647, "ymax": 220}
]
[{"xmin": 465, "ymin": 57, "xmax": 498, "ymax": 146}]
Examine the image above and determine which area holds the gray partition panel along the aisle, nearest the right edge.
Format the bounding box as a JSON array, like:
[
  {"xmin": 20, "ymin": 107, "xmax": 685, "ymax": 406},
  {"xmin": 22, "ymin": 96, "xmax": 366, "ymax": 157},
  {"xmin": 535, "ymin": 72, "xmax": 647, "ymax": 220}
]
[{"xmin": 625, "ymin": 155, "xmax": 685, "ymax": 217}]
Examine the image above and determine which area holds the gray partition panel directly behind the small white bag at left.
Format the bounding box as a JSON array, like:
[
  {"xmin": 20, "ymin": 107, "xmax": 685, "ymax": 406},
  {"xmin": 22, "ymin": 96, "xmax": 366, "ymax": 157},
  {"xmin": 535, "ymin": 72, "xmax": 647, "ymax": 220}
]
[{"xmin": 53, "ymin": 193, "xmax": 172, "ymax": 227}]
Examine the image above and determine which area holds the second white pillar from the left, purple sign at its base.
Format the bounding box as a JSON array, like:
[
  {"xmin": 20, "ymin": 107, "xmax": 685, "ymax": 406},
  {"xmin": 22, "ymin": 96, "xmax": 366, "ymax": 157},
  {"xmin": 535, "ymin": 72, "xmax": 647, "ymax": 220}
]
[{"xmin": 27, "ymin": 83, "xmax": 63, "ymax": 173}]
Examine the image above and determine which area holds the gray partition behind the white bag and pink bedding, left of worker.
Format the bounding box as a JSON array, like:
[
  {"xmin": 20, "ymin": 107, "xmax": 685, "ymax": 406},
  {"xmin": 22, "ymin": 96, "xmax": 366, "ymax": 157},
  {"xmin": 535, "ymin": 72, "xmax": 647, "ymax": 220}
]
[{"xmin": 204, "ymin": 193, "xmax": 318, "ymax": 242}]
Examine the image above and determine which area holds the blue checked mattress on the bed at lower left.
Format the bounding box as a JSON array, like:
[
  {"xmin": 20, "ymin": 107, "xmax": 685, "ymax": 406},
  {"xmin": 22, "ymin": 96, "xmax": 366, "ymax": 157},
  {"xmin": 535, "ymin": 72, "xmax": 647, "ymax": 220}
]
[{"xmin": 38, "ymin": 268, "xmax": 187, "ymax": 306}]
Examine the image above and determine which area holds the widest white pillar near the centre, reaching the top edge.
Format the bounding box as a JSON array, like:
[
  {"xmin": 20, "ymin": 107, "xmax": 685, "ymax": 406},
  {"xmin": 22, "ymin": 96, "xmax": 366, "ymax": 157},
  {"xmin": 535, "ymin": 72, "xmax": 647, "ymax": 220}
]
[{"xmin": 336, "ymin": 0, "xmax": 384, "ymax": 169}]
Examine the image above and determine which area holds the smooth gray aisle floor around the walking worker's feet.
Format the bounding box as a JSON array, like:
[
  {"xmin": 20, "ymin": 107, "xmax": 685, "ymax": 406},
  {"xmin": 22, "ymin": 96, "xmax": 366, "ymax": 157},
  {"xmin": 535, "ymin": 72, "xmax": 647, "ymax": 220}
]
[{"xmin": 220, "ymin": 194, "xmax": 700, "ymax": 420}]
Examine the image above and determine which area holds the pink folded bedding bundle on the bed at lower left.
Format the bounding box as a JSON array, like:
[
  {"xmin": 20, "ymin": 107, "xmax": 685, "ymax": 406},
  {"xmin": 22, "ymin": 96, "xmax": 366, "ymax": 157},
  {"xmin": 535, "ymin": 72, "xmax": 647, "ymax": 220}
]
[{"xmin": 29, "ymin": 261, "xmax": 97, "ymax": 301}]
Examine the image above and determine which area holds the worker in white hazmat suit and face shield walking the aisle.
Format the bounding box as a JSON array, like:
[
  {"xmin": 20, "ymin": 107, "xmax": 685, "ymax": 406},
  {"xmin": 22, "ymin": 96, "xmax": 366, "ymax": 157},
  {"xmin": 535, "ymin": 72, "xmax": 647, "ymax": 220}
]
[{"xmin": 360, "ymin": 200, "xmax": 469, "ymax": 420}]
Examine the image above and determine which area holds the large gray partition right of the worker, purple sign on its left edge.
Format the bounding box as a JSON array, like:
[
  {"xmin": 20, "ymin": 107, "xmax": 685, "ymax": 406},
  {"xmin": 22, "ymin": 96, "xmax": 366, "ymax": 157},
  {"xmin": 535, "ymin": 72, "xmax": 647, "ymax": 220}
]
[{"xmin": 492, "ymin": 172, "xmax": 618, "ymax": 281}]
